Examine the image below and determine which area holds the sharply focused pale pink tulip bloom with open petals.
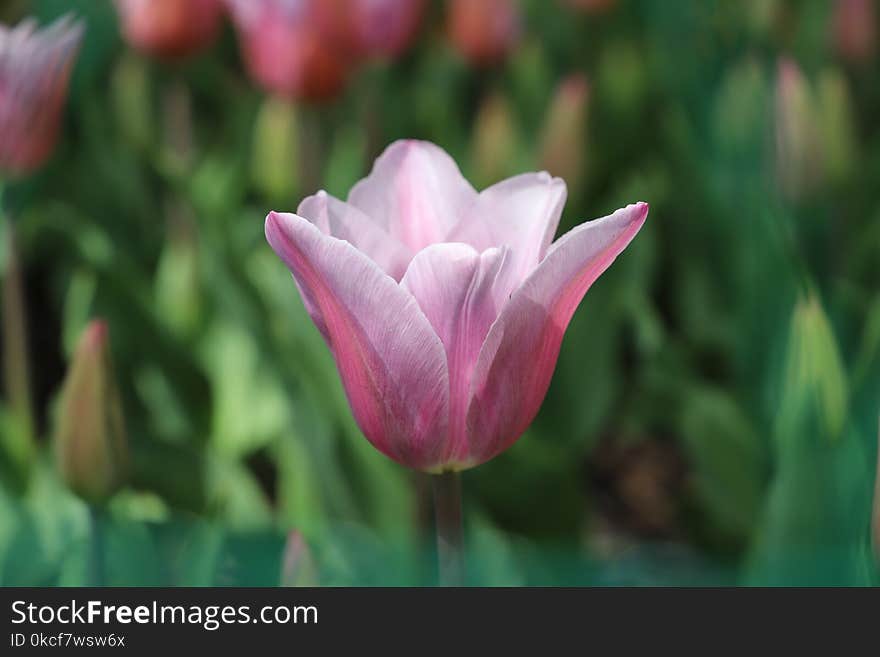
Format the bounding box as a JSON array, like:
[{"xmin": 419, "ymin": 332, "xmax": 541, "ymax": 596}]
[{"xmin": 266, "ymin": 141, "xmax": 648, "ymax": 473}]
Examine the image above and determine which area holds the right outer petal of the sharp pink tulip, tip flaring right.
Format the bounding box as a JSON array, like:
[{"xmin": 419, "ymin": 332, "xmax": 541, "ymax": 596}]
[{"xmin": 468, "ymin": 203, "xmax": 648, "ymax": 465}]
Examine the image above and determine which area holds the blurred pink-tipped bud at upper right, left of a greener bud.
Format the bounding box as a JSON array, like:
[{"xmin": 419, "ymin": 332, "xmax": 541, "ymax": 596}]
[{"xmin": 776, "ymin": 58, "xmax": 822, "ymax": 200}]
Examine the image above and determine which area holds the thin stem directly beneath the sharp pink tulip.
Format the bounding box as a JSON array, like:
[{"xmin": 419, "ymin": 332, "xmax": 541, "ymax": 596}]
[{"xmin": 431, "ymin": 472, "xmax": 464, "ymax": 586}]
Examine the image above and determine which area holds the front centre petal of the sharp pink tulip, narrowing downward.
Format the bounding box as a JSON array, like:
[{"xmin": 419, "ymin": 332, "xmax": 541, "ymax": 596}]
[{"xmin": 400, "ymin": 243, "xmax": 510, "ymax": 467}]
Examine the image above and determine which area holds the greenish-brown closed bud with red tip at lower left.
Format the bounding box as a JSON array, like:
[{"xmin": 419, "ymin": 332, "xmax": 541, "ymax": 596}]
[{"xmin": 55, "ymin": 320, "xmax": 128, "ymax": 503}]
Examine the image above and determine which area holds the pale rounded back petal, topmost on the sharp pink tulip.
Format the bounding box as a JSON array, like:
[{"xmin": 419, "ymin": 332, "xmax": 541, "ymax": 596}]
[{"xmin": 348, "ymin": 140, "xmax": 477, "ymax": 251}]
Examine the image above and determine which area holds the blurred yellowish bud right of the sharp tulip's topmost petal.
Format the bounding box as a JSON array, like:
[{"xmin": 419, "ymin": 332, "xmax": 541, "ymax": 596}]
[{"xmin": 473, "ymin": 93, "xmax": 517, "ymax": 187}]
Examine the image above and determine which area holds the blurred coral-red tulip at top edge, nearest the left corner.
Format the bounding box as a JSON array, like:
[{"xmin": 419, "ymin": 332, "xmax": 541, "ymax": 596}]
[{"xmin": 116, "ymin": 0, "xmax": 223, "ymax": 58}]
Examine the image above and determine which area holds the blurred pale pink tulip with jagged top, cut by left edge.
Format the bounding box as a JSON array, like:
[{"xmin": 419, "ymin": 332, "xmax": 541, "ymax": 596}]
[{"xmin": 0, "ymin": 17, "xmax": 83, "ymax": 174}]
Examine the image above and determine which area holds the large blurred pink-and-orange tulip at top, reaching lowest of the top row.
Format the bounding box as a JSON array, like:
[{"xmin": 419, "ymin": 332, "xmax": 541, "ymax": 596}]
[{"xmin": 227, "ymin": 0, "xmax": 348, "ymax": 101}]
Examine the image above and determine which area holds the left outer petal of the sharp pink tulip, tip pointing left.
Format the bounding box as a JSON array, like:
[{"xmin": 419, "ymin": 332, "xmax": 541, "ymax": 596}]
[{"xmin": 266, "ymin": 212, "xmax": 449, "ymax": 469}]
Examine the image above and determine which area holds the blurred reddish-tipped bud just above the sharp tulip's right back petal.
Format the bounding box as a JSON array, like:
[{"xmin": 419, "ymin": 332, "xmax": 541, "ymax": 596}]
[{"xmin": 539, "ymin": 75, "xmax": 590, "ymax": 188}]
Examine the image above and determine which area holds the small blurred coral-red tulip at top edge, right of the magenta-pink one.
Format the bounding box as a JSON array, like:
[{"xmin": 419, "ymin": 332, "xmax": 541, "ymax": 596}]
[{"xmin": 448, "ymin": 0, "xmax": 522, "ymax": 66}]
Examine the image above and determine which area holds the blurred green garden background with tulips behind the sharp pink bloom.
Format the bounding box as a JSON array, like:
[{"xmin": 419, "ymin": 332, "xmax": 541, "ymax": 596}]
[{"xmin": 0, "ymin": 0, "xmax": 880, "ymax": 585}]
